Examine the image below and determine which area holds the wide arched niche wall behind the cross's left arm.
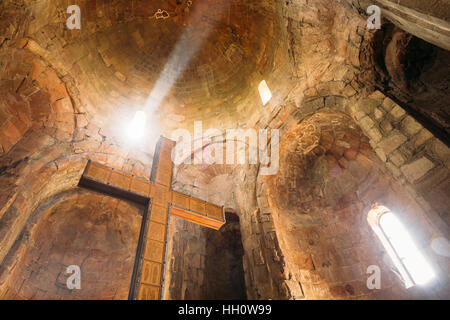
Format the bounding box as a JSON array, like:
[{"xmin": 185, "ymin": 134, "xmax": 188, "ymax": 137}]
[{"xmin": 0, "ymin": 189, "xmax": 143, "ymax": 300}]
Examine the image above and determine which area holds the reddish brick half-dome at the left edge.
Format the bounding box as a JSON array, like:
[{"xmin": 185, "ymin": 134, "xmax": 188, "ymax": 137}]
[{"xmin": 0, "ymin": 49, "xmax": 74, "ymax": 154}]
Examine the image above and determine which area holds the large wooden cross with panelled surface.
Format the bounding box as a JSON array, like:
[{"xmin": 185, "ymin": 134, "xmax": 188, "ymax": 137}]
[{"xmin": 79, "ymin": 137, "xmax": 225, "ymax": 300}]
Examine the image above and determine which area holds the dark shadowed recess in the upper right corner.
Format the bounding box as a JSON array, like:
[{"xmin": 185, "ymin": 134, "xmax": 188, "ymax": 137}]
[{"xmin": 363, "ymin": 23, "xmax": 450, "ymax": 144}]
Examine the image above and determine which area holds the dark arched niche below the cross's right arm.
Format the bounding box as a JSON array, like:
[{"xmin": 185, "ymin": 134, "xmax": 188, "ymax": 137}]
[{"xmin": 164, "ymin": 212, "xmax": 246, "ymax": 300}]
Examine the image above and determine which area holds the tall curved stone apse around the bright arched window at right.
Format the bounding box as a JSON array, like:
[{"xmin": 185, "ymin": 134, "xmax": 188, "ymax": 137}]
[{"xmin": 258, "ymin": 109, "xmax": 445, "ymax": 299}]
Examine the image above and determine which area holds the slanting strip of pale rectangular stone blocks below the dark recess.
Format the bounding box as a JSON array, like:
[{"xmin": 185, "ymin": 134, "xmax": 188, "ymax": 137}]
[{"xmin": 351, "ymin": 92, "xmax": 450, "ymax": 234}]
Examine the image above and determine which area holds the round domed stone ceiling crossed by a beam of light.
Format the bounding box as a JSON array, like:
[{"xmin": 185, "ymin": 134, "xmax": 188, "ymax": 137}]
[{"xmin": 25, "ymin": 0, "xmax": 276, "ymax": 136}]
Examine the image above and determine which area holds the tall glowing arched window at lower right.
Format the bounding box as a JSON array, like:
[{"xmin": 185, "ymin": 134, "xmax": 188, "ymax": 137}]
[{"xmin": 367, "ymin": 205, "xmax": 436, "ymax": 288}]
